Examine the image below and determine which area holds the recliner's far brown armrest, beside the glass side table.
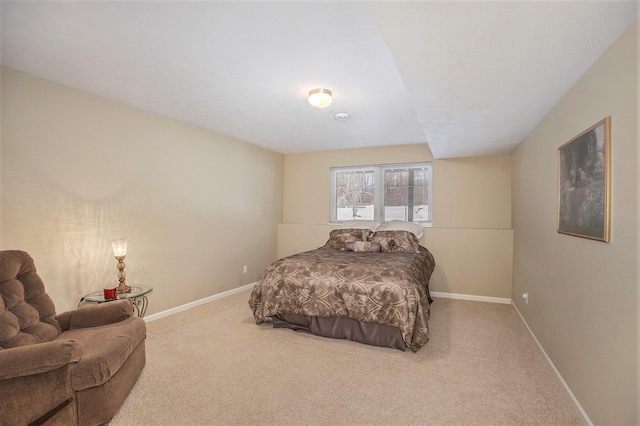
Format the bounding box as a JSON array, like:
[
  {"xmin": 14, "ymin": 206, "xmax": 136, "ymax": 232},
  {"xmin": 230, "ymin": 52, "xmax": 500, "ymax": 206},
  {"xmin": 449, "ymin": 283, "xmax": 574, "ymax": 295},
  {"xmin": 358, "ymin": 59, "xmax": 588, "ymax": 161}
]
[{"xmin": 56, "ymin": 300, "xmax": 133, "ymax": 331}]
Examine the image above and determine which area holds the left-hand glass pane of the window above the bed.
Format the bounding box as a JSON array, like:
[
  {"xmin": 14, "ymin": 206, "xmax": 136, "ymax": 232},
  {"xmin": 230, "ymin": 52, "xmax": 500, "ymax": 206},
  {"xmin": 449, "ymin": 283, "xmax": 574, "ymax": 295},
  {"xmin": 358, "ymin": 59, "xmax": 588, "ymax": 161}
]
[{"xmin": 335, "ymin": 170, "xmax": 375, "ymax": 221}]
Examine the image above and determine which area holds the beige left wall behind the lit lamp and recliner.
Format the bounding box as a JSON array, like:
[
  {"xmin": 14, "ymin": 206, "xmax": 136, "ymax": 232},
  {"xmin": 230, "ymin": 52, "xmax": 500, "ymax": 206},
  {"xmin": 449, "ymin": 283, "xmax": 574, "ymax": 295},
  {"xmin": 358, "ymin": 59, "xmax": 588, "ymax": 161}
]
[{"xmin": 0, "ymin": 68, "xmax": 283, "ymax": 313}]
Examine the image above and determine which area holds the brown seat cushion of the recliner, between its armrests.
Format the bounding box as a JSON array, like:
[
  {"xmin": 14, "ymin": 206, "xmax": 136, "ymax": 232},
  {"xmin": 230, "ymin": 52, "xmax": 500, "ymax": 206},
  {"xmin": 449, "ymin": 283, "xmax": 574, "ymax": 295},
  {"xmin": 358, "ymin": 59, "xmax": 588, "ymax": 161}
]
[{"xmin": 58, "ymin": 317, "xmax": 147, "ymax": 391}]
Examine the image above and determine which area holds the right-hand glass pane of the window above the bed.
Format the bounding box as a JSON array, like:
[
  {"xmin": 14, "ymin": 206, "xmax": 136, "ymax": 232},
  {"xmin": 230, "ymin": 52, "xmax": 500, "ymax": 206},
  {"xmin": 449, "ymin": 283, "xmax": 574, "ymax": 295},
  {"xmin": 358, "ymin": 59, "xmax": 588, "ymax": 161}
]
[{"xmin": 383, "ymin": 168, "xmax": 430, "ymax": 222}]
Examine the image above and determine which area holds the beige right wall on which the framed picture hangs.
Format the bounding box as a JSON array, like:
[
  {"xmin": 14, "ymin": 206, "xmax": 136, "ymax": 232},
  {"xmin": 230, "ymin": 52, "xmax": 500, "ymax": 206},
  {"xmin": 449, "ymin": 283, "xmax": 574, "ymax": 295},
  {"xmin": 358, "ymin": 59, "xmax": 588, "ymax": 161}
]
[{"xmin": 513, "ymin": 20, "xmax": 640, "ymax": 425}]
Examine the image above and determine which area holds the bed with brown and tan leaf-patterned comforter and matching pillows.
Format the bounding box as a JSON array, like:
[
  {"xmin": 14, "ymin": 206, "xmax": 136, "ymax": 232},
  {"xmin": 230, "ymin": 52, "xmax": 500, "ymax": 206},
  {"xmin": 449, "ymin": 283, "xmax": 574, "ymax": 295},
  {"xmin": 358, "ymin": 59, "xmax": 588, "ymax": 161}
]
[{"xmin": 249, "ymin": 228, "xmax": 435, "ymax": 351}]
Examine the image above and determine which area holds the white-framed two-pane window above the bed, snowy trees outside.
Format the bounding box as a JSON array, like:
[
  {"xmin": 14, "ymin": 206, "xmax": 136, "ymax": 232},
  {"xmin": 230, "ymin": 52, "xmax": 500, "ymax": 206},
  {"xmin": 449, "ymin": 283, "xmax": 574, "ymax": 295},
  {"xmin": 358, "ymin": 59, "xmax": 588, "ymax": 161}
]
[{"xmin": 331, "ymin": 163, "xmax": 431, "ymax": 223}]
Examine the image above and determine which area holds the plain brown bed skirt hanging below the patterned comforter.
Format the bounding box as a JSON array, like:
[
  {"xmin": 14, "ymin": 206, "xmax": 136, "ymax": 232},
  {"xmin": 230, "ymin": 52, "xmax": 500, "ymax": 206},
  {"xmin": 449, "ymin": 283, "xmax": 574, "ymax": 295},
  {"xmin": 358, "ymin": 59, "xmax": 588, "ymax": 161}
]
[{"xmin": 273, "ymin": 313, "xmax": 407, "ymax": 351}]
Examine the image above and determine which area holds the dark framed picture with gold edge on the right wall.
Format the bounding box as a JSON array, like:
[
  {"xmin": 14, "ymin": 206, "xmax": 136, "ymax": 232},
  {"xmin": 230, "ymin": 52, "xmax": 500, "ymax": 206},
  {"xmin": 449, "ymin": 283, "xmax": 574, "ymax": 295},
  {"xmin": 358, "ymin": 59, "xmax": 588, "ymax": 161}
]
[{"xmin": 558, "ymin": 117, "xmax": 611, "ymax": 242}]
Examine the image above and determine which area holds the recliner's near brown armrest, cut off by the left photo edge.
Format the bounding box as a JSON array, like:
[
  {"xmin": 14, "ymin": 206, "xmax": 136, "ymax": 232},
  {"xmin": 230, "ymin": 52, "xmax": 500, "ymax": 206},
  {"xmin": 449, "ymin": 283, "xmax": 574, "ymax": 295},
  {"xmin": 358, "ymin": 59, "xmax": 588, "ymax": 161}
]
[{"xmin": 0, "ymin": 339, "xmax": 82, "ymax": 380}]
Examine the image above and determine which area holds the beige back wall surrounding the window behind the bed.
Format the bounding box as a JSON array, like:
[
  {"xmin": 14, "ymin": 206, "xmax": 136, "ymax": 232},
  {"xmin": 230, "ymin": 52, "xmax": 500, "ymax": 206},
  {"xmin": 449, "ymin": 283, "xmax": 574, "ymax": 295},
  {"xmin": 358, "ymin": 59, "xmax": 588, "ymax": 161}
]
[{"xmin": 278, "ymin": 144, "xmax": 513, "ymax": 298}]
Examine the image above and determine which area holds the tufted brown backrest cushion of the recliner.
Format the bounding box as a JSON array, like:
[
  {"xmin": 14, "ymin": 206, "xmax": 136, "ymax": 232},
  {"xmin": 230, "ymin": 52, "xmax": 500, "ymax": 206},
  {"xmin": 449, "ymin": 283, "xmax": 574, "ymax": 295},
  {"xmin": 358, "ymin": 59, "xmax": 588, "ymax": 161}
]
[{"xmin": 0, "ymin": 250, "xmax": 62, "ymax": 349}]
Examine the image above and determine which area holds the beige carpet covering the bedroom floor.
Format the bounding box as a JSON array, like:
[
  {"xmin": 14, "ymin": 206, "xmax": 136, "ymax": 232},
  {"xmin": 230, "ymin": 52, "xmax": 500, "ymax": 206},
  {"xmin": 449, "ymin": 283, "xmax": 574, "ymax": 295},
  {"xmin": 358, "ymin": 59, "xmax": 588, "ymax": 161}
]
[{"xmin": 110, "ymin": 291, "xmax": 580, "ymax": 426}]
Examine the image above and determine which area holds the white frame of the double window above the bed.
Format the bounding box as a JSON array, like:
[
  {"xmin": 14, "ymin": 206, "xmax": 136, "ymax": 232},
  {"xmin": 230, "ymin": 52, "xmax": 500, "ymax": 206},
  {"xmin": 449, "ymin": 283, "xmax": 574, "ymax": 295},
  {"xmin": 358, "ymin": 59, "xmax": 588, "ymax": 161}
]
[{"xmin": 330, "ymin": 161, "xmax": 433, "ymax": 226}]
